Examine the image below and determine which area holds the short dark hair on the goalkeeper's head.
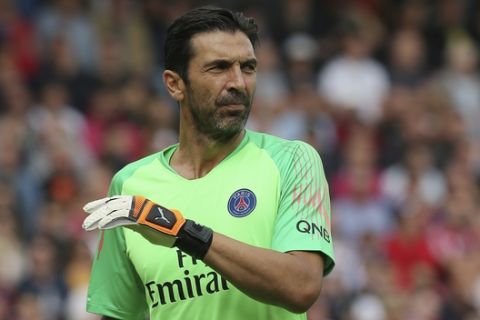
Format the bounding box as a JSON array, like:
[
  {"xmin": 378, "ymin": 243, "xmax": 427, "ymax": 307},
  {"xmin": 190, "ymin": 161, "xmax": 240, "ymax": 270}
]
[{"xmin": 164, "ymin": 6, "xmax": 258, "ymax": 83}]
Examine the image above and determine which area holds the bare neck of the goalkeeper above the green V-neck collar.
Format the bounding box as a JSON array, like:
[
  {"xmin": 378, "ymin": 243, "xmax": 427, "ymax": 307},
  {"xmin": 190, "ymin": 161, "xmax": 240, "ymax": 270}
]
[{"xmin": 170, "ymin": 126, "xmax": 245, "ymax": 180}]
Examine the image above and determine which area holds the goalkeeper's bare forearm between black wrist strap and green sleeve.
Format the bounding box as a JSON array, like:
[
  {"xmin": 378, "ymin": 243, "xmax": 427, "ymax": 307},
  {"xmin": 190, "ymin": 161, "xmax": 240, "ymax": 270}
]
[{"xmin": 204, "ymin": 233, "xmax": 323, "ymax": 312}]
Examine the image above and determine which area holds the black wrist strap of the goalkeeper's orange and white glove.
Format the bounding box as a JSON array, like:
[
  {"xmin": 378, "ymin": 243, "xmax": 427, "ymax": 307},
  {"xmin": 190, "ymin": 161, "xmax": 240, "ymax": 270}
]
[{"xmin": 175, "ymin": 219, "xmax": 213, "ymax": 260}]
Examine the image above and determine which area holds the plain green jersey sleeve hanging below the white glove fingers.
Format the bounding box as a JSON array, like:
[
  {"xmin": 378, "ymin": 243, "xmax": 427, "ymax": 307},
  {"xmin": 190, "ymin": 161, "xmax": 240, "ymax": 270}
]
[{"xmin": 87, "ymin": 174, "xmax": 148, "ymax": 320}]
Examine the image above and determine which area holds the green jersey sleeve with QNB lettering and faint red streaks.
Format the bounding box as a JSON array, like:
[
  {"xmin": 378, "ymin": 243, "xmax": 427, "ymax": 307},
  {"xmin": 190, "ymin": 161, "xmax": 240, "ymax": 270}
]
[{"xmin": 272, "ymin": 142, "xmax": 335, "ymax": 274}]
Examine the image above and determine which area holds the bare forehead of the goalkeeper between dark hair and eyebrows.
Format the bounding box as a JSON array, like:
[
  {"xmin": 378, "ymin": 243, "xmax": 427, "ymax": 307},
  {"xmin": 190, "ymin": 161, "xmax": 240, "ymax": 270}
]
[{"xmin": 191, "ymin": 31, "xmax": 255, "ymax": 63}]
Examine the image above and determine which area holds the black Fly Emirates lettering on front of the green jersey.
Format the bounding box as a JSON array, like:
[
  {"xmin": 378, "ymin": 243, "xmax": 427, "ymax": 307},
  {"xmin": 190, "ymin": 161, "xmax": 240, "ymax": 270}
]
[{"xmin": 145, "ymin": 250, "xmax": 229, "ymax": 308}]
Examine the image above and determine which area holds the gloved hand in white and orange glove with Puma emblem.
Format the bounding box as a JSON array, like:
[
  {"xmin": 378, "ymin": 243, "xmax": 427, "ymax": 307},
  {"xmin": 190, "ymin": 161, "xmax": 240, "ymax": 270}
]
[{"xmin": 82, "ymin": 196, "xmax": 185, "ymax": 247}]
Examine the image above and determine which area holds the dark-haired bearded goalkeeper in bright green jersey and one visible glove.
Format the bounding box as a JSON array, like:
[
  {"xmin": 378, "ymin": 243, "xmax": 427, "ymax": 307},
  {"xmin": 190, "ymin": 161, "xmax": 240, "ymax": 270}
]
[{"xmin": 84, "ymin": 7, "xmax": 334, "ymax": 320}]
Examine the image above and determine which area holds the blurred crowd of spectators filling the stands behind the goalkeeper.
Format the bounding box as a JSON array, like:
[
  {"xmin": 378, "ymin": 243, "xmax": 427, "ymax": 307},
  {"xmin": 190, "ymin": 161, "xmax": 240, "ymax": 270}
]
[{"xmin": 0, "ymin": 0, "xmax": 480, "ymax": 320}]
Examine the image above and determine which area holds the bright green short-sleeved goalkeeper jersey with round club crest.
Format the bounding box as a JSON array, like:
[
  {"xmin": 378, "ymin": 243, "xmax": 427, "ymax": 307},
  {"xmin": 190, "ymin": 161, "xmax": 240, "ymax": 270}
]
[{"xmin": 87, "ymin": 130, "xmax": 334, "ymax": 320}]
